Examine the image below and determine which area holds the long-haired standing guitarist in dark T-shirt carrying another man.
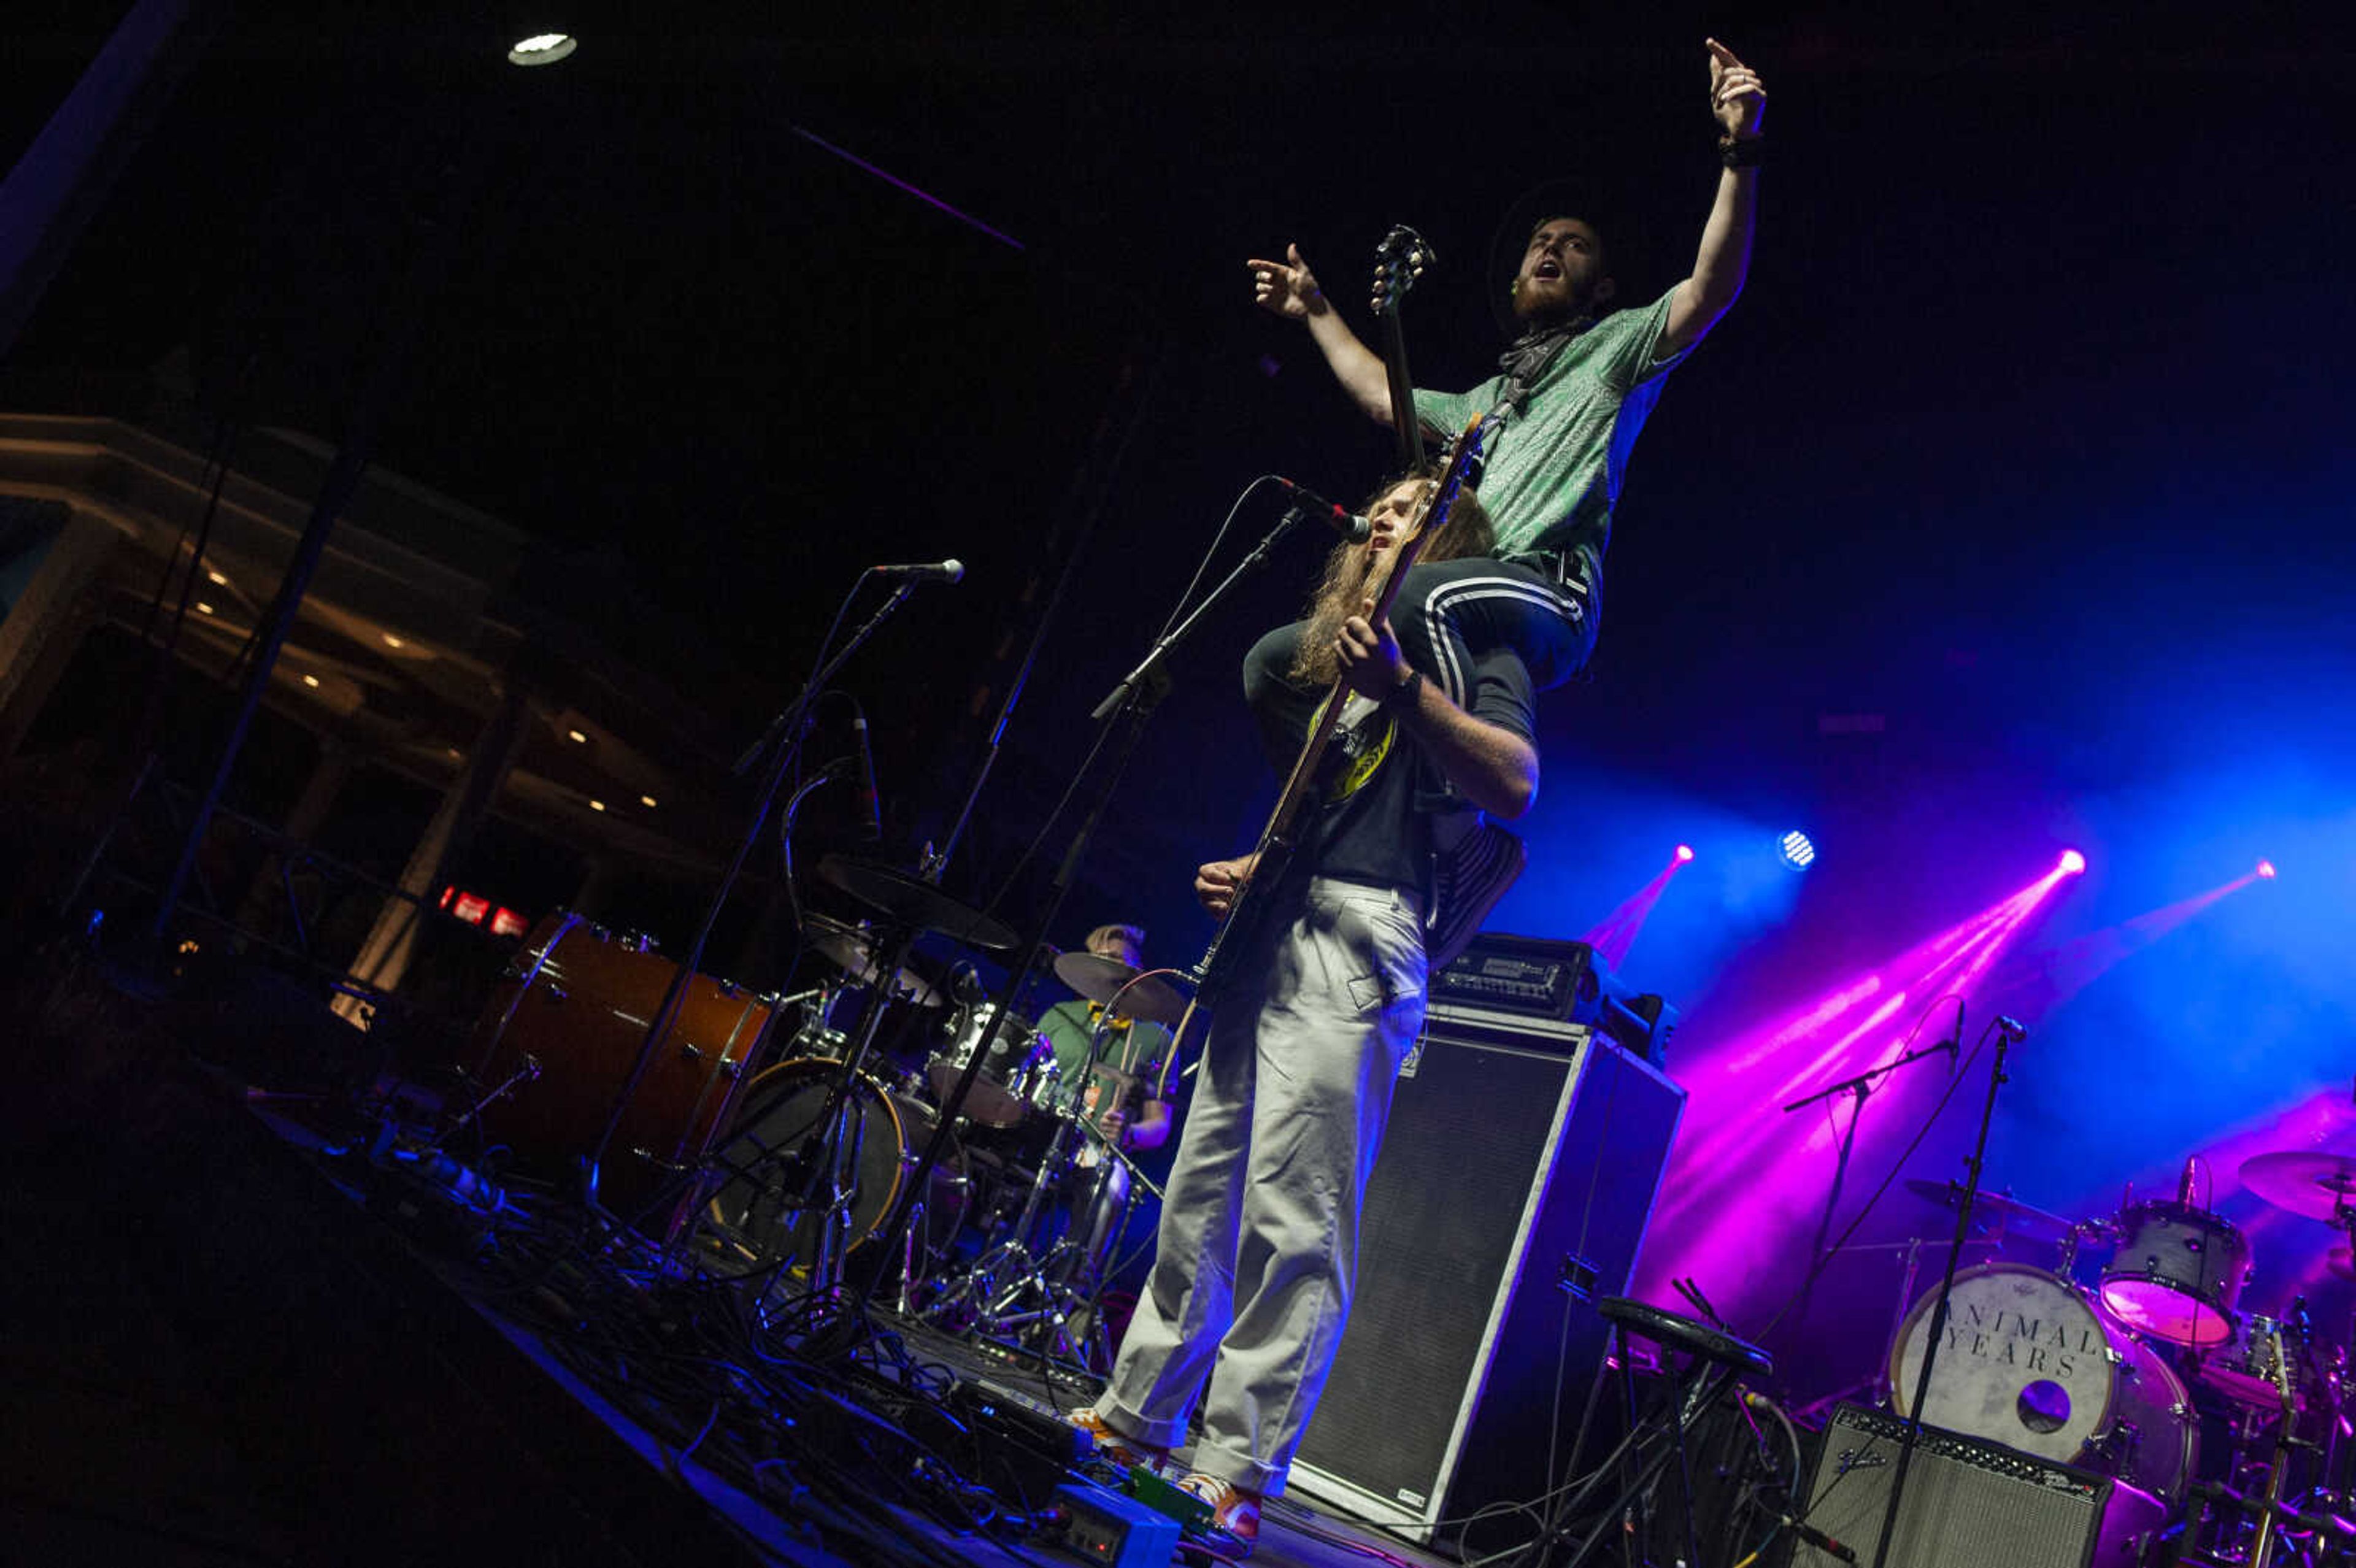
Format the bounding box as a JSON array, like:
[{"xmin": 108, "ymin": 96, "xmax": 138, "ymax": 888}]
[{"xmin": 1072, "ymin": 464, "xmax": 1539, "ymax": 1549}]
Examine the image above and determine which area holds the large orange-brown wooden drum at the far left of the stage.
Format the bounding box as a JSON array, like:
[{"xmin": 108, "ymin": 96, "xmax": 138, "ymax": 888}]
[{"xmin": 469, "ymin": 913, "xmax": 775, "ymax": 1234}]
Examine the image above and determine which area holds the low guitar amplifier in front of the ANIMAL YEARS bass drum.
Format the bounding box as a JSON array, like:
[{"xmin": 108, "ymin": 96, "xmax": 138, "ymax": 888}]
[{"xmin": 1790, "ymin": 1405, "xmax": 2168, "ymax": 1568}]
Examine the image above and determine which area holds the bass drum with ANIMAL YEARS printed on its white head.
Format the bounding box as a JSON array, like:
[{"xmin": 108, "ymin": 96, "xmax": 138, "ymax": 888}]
[{"xmin": 1890, "ymin": 1264, "xmax": 2201, "ymax": 1502}]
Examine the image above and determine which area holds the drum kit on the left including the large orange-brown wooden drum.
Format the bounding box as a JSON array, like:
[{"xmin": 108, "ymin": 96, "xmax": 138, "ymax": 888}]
[{"xmin": 457, "ymin": 859, "xmax": 1185, "ymax": 1370}]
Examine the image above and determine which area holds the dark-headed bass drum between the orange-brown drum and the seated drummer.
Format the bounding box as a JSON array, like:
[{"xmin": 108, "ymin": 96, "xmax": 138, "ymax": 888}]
[{"xmin": 709, "ymin": 1059, "xmax": 968, "ymax": 1283}]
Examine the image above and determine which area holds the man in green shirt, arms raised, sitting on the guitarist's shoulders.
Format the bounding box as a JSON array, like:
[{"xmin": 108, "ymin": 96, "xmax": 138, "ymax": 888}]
[{"xmin": 1244, "ymin": 37, "xmax": 1767, "ymax": 690}]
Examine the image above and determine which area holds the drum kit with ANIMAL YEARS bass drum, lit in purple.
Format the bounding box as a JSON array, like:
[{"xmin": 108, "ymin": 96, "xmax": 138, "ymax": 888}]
[{"xmin": 1873, "ymin": 1151, "xmax": 2356, "ymax": 1563}]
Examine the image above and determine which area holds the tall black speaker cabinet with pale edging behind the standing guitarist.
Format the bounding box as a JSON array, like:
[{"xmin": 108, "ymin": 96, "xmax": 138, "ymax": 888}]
[{"xmin": 1291, "ymin": 1008, "xmax": 1685, "ymax": 1540}]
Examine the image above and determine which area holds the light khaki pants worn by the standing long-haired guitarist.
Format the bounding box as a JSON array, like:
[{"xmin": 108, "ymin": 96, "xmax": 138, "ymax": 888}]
[{"xmin": 1096, "ymin": 878, "xmax": 1425, "ymax": 1493}]
